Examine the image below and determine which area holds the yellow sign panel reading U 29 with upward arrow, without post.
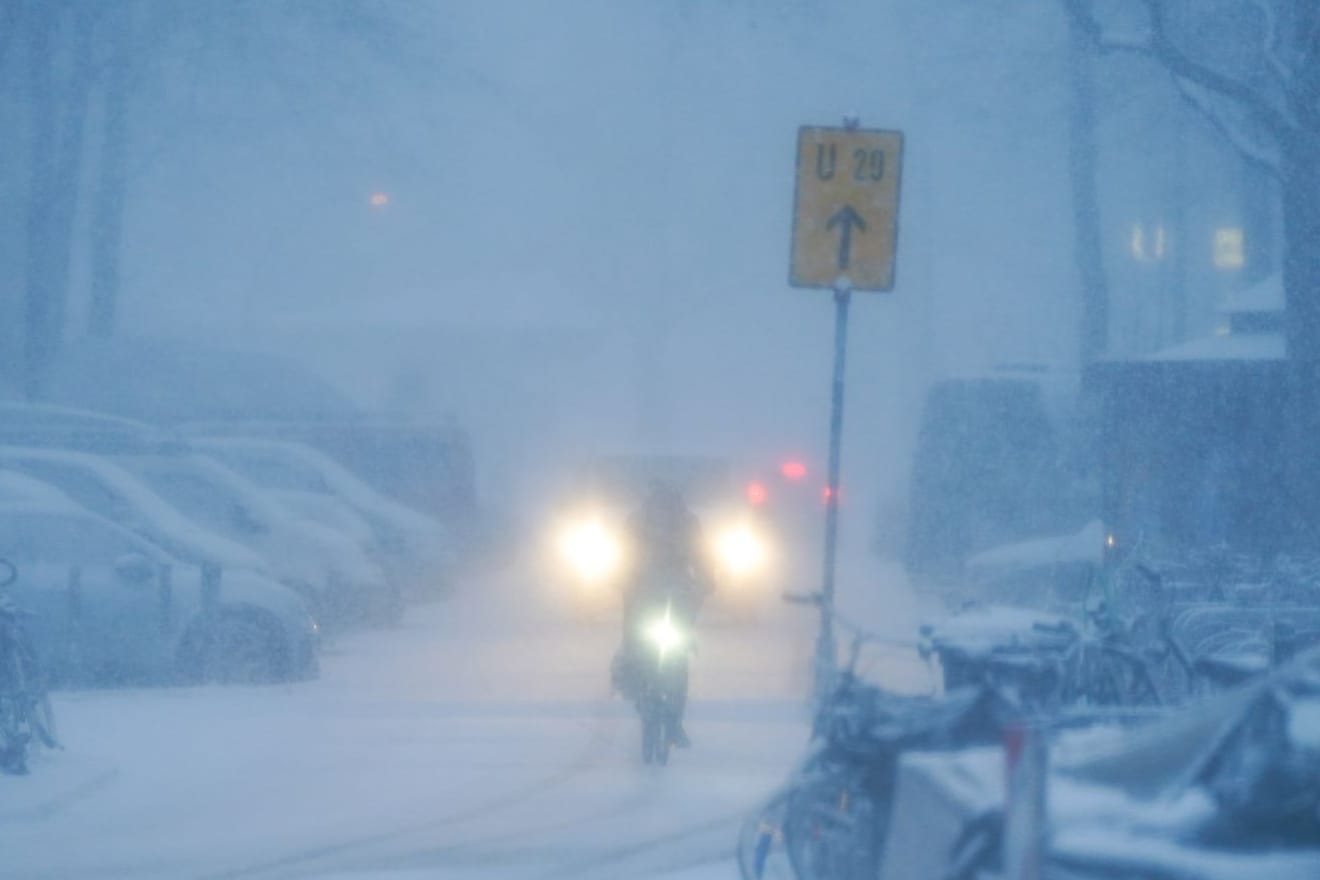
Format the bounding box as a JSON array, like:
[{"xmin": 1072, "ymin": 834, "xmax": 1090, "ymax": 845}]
[{"xmin": 789, "ymin": 125, "xmax": 903, "ymax": 290}]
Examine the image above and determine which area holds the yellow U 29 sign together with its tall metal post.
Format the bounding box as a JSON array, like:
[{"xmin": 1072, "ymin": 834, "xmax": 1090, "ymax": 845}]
[{"xmin": 789, "ymin": 117, "xmax": 903, "ymax": 699}]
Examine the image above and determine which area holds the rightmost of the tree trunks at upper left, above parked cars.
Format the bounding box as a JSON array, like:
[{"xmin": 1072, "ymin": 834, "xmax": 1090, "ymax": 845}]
[{"xmin": 87, "ymin": 3, "xmax": 132, "ymax": 338}]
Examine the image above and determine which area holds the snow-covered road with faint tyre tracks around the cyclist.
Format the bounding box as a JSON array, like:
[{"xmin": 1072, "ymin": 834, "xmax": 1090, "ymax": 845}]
[{"xmin": 0, "ymin": 562, "xmax": 929, "ymax": 879}]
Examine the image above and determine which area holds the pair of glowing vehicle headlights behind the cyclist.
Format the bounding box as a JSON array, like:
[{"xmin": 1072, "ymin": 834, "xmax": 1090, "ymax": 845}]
[{"xmin": 556, "ymin": 516, "xmax": 771, "ymax": 584}]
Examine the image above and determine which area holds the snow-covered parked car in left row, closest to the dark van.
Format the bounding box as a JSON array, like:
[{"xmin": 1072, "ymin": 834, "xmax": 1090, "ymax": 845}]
[{"xmin": 191, "ymin": 438, "xmax": 455, "ymax": 595}]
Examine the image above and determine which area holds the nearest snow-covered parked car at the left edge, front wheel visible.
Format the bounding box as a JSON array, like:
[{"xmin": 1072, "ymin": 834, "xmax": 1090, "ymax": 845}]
[{"xmin": 0, "ymin": 498, "xmax": 317, "ymax": 683}]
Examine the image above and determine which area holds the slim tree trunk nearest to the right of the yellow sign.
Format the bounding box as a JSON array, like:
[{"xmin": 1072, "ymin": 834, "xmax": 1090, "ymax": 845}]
[{"xmin": 1068, "ymin": 16, "xmax": 1109, "ymax": 365}]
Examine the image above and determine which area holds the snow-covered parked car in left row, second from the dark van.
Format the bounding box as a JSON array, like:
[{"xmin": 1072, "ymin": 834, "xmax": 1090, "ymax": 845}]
[{"xmin": 111, "ymin": 453, "xmax": 401, "ymax": 623}]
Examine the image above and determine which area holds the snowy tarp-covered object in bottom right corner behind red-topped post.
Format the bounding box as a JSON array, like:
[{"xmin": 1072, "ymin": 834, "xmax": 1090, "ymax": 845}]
[{"xmin": 880, "ymin": 652, "xmax": 1320, "ymax": 880}]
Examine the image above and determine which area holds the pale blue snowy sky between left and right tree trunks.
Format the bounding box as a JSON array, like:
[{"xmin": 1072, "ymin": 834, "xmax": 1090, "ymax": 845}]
[{"xmin": 93, "ymin": 0, "xmax": 1235, "ymax": 522}]
